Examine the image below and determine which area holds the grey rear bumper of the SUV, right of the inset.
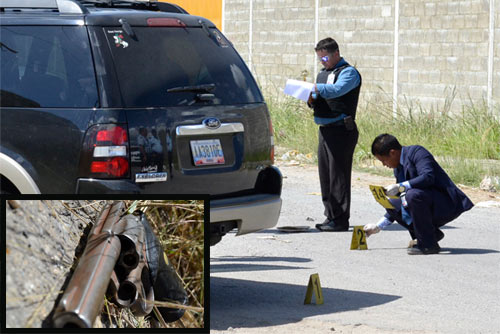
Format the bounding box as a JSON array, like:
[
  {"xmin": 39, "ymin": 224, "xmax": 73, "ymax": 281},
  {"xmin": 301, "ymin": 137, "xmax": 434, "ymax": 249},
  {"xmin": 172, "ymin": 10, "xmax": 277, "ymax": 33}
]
[{"xmin": 210, "ymin": 194, "xmax": 281, "ymax": 235}]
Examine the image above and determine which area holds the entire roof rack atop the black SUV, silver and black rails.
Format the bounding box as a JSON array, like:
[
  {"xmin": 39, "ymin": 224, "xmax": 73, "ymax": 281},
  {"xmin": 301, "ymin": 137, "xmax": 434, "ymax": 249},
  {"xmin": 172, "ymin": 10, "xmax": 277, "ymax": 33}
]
[{"xmin": 0, "ymin": 0, "xmax": 189, "ymax": 14}]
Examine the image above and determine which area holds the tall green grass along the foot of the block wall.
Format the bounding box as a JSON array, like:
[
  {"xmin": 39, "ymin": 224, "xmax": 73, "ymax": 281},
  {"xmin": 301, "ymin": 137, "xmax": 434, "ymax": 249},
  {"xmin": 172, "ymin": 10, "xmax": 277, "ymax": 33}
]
[{"xmin": 266, "ymin": 92, "xmax": 500, "ymax": 190}]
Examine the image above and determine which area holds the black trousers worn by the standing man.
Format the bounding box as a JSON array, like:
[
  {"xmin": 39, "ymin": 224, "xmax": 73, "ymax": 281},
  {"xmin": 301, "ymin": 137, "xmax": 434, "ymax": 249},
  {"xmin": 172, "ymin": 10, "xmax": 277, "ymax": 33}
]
[{"xmin": 318, "ymin": 125, "xmax": 359, "ymax": 226}]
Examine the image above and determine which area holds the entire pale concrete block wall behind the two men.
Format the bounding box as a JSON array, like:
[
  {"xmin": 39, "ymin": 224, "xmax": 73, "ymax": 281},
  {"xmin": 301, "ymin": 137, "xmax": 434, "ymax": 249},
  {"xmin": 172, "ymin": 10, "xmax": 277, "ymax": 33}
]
[{"xmin": 223, "ymin": 0, "xmax": 500, "ymax": 110}]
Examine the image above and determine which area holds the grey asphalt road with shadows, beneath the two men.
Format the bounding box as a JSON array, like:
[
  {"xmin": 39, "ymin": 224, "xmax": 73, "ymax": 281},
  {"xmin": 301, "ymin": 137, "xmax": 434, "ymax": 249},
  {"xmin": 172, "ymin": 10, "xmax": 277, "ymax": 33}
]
[{"xmin": 210, "ymin": 167, "xmax": 500, "ymax": 334}]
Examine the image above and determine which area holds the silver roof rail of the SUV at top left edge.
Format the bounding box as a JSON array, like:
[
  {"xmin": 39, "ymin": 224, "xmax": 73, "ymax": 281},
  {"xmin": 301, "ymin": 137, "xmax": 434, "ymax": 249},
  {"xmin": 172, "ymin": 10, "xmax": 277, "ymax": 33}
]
[{"xmin": 0, "ymin": 0, "xmax": 88, "ymax": 14}]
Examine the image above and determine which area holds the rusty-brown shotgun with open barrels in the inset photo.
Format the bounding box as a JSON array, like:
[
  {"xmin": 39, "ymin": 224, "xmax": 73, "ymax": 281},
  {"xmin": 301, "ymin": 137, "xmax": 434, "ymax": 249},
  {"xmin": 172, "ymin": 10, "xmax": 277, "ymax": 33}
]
[{"xmin": 53, "ymin": 201, "xmax": 188, "ymax": 328}]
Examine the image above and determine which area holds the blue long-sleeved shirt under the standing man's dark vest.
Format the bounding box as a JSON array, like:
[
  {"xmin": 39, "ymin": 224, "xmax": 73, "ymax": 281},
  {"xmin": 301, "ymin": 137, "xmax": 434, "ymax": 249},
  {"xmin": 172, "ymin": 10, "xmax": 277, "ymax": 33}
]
[{"xmin": 314, "ymin": 58, "xmax": 361, "ymax": 125}]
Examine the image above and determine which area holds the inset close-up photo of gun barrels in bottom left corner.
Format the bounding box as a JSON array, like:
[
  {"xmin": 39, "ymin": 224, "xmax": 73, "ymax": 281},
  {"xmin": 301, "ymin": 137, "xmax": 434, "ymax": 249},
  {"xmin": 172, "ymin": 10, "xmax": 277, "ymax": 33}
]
[{"xmin": 5, "ymin": 200, "xmax": 208, "ymax": 332}]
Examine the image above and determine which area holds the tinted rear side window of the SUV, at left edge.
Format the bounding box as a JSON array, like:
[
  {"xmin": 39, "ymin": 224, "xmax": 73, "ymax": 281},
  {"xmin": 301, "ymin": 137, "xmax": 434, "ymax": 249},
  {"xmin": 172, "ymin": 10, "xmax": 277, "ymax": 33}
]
[{"xmin": 0, "ymin": 26, "xmax": 98, "ymax": 108}]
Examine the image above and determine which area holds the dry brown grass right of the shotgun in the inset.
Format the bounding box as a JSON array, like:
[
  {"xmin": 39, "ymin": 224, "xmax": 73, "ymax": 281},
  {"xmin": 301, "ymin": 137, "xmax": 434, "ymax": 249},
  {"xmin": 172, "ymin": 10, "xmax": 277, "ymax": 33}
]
[{"xmin": 108, "ymin": 200, "xmax": 205, "ymax": 328}]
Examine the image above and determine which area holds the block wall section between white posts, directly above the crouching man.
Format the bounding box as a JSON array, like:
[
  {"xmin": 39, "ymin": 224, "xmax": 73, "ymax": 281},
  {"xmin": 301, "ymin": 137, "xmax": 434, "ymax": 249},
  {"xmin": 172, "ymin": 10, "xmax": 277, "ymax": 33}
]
[{"xmin": 398, "ymin": 0, "xmax": 492, "ymax": 110}]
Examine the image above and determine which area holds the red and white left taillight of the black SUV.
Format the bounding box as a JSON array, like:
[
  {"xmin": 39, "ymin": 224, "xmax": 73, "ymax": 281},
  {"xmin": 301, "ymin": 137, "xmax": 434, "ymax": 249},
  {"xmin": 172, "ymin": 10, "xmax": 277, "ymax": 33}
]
[{"xmin": 81, "ymin": 124, "xmax": 130, "ymax": 178}]
